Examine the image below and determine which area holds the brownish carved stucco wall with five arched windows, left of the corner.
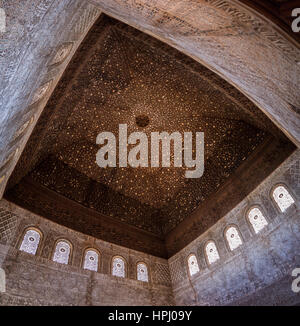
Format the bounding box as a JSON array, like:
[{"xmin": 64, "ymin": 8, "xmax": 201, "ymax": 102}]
[{"xmin": 0, "ymin": 200, "xmax": 174, "ymax": 305}]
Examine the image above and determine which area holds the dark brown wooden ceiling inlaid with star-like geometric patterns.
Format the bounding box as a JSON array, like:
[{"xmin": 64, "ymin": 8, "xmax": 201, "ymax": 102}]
[{"xmin": 6, "ymin": 15, "xmax": 294, "ymax": 257}]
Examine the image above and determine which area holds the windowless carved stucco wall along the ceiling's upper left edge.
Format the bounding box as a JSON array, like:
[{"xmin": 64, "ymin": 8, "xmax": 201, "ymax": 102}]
[{"xmin": 0, "ymin": 0, "xmax": 101, "ymax": 197}]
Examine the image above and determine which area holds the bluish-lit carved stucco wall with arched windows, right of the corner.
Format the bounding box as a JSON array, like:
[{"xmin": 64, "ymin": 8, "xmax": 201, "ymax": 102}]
[{"xmin": 169, "ymin": 150, "xmax": 300, "ymax": 305}]
